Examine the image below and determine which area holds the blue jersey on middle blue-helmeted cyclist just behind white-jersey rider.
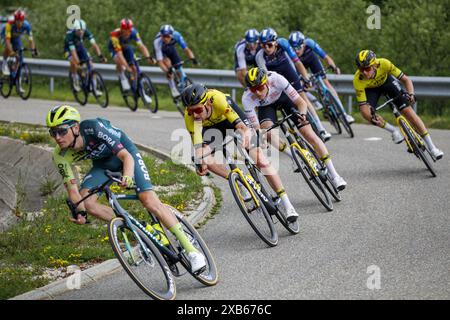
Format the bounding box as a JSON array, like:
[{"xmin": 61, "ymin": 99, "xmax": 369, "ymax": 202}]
[{"xmin": 255, "ymin": 38, "xmax": 303, "ymax": 92}]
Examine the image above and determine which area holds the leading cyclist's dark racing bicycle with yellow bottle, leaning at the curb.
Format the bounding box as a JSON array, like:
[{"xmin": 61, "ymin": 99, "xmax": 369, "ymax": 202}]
[{"xmin": 67, "ymin": 170, "xmax": 218, "ymax": 300}]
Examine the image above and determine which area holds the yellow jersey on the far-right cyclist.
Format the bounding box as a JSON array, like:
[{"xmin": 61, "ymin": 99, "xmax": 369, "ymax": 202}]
[{"xmin": 353, "ymin": 58, "xmax": 403, "ymax": 105}]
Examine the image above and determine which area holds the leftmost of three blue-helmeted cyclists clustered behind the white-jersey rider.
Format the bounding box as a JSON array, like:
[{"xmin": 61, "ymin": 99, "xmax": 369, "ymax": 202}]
[{"xmin": 234, "ymin": 29, "xmax": 261, "ymax": 87}]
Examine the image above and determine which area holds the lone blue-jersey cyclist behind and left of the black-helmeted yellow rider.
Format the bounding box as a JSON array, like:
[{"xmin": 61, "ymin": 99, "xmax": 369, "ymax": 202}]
[{"xmin": 153, "ymin": 24, "xmax": 198, "ymax": 98}]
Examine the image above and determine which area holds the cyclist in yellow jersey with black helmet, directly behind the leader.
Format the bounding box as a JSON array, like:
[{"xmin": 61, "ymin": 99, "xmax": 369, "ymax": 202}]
[{"xmin": 181, "ymin": 83, "xmax": 298, "ymax": 222}]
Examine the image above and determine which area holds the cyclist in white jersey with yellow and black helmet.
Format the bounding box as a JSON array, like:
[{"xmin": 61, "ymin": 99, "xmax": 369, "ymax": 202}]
[{"xmin": 242, "ymin": 68, "xmax": 347, "ymax": 190}]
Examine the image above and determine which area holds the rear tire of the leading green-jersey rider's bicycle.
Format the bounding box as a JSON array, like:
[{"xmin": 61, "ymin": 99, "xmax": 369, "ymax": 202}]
[{"xmin": 167, "ymin": 206, "xmax": 219, "ymax": 286}]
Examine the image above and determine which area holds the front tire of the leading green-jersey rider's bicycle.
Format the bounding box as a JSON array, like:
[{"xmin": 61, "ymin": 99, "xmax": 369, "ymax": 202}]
[{"xmin": 108, "ymin": 217, "xmax": 176, "ymax": 300}]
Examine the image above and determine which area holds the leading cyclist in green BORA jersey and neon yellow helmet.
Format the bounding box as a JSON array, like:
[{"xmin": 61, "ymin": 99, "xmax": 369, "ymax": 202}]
[{"xmin": 46, "ymin": 105, "xmax": 206, "ymax": 272}]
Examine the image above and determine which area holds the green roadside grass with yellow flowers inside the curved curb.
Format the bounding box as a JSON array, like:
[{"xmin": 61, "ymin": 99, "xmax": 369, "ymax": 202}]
[{"xmin": 0, "ymin": 123, "xmax": 203, "ymax": 299}]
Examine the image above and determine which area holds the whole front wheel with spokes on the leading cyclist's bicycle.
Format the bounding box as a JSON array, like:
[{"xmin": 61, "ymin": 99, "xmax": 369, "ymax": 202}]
[{"xmin": 108, "ymin": 217, "xmax": 176, "ymax": 300}]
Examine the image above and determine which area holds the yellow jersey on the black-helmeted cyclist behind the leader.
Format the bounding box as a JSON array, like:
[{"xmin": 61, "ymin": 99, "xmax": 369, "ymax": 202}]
[{"xmin": 184, "ymin": 89, "xmax": 243, "ymax": 146}]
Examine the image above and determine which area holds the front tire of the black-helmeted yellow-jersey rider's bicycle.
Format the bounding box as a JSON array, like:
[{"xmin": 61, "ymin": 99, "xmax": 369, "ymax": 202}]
[{"xmin": 228, "ymin": 172, "xmax": 278, "ymax": 247}]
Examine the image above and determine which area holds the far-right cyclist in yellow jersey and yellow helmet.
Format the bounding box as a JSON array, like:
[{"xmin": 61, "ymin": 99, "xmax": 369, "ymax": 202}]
[{"xmin": 353, "ymin": 50, "xmax": 444, "ymax": 159}]
